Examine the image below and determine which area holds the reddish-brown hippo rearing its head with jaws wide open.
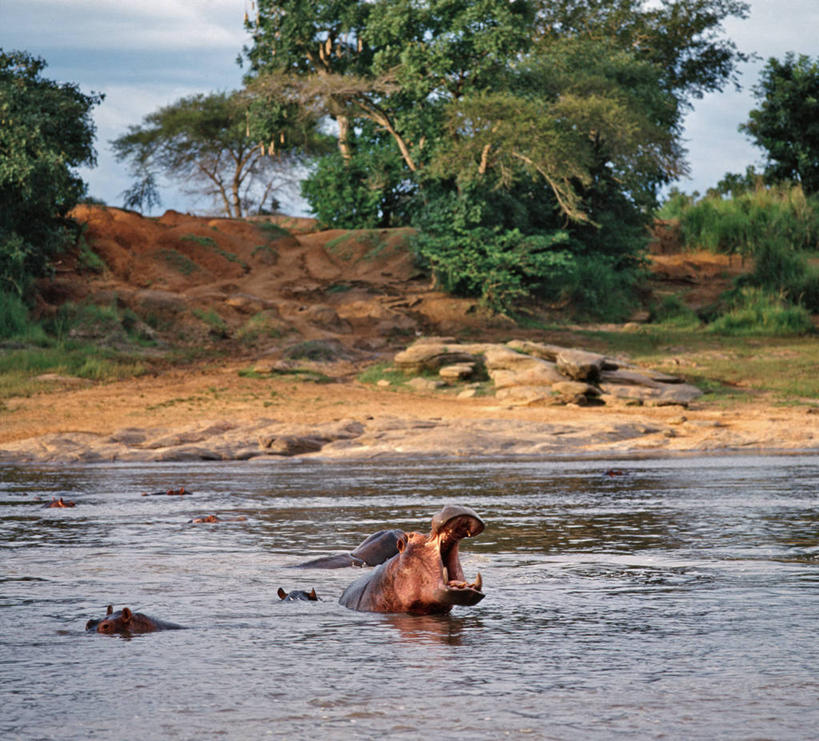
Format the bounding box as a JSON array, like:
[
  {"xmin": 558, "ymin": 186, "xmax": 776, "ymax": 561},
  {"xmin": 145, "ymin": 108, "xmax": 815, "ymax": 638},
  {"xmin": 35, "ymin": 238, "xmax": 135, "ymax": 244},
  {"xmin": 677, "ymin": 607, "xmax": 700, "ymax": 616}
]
[{"xmin": 339, "ymin": 504, "xmax": 485, "ymax": 614}]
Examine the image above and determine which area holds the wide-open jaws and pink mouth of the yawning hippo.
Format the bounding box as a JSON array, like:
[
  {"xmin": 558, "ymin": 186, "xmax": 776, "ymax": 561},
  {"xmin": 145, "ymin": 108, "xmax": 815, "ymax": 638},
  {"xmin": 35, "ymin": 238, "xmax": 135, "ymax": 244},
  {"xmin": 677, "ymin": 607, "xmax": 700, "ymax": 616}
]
[{"xmin": 432, "ymin": 505, "xmax": 486, "ymax": 605}]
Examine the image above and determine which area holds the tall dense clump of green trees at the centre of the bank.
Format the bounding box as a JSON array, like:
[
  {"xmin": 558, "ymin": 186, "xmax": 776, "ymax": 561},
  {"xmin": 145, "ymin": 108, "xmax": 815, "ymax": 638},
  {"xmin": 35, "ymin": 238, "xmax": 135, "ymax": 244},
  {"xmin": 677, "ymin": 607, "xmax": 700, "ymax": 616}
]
[{"xmin": 245, "ymin": 0, "xmax": 748, "ymax": 316}]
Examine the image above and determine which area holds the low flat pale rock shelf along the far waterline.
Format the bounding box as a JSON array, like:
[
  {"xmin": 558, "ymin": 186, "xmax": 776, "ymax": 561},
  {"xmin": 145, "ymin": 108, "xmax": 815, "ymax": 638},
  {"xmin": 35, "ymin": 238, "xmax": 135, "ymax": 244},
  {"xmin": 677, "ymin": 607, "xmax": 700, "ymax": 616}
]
[{"xmin": 0, "ymin": 414, "xmax": 712, "ymax": 463}]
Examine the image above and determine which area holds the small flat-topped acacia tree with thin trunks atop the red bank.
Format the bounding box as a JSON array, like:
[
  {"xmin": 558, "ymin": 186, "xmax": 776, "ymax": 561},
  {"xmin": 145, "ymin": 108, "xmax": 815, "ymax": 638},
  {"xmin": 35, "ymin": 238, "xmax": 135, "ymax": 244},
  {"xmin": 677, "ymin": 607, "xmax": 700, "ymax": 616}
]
[{"xmin": 112, "ymin": 93, "xmax": 322, "ymax": 218}]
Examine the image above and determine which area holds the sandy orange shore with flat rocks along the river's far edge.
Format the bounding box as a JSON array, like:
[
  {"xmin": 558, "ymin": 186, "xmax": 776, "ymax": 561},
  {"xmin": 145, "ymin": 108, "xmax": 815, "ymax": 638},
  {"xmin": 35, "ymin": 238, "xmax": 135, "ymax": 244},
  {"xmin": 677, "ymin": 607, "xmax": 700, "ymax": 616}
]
[{"xmin": 0, "ymin": 363, "xmax": 819, "ymax": 462}]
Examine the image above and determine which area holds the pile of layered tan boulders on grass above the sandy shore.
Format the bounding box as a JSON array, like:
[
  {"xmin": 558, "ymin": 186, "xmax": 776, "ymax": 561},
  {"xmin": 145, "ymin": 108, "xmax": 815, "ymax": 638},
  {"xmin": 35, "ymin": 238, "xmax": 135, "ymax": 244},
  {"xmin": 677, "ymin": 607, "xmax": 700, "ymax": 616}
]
[{"xmin": 394, "ymin": 337, "xmax": 702, "ymax": 406}]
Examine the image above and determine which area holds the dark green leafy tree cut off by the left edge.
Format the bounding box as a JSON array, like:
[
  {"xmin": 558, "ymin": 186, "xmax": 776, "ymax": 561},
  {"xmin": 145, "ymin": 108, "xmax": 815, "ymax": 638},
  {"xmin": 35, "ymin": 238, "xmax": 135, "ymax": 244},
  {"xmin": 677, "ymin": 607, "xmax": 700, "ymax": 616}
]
[{"xmin": 0, "ymin": 49, "xmax": 103, "ymax": 295}]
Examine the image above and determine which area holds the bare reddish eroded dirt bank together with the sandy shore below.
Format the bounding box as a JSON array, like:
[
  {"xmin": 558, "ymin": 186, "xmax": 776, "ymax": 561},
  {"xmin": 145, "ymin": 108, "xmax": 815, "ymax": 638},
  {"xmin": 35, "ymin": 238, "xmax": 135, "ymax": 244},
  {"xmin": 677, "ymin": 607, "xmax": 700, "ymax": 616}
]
[{"xmin": 0, "ymin": 206, "xmax": 819, "ymax": 462}]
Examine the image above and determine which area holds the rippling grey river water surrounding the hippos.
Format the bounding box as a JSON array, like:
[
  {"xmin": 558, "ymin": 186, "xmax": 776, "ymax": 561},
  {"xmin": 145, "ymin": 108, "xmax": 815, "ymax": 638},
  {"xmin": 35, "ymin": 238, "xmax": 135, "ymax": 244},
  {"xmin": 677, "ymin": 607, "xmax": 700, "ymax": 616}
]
[{"xmin": 0, "ymin": 456, "xmax": 819, "ymax": 739}]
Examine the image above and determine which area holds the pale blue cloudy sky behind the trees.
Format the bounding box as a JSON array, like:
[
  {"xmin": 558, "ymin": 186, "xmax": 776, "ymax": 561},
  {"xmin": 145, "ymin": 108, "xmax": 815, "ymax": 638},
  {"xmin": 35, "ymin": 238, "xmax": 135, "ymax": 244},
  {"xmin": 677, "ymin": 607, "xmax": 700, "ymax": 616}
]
[{"xmin": 0, "ymin": 0, "xmax": 819, "ymax": 215}]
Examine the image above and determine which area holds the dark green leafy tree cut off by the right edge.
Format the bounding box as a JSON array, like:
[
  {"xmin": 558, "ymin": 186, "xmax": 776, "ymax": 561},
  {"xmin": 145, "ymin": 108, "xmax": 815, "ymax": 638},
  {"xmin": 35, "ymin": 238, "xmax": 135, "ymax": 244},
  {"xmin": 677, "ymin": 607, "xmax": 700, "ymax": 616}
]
[{"xmin": 739, "ymin": 53, "xmax": 819, "ymax": 194}]
